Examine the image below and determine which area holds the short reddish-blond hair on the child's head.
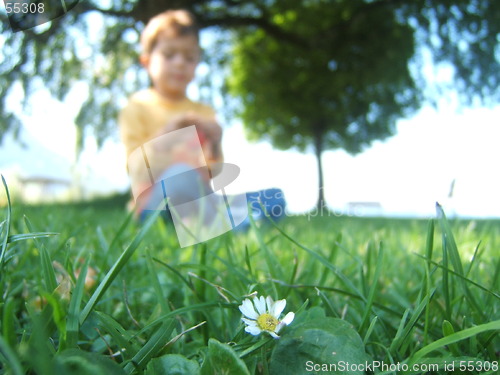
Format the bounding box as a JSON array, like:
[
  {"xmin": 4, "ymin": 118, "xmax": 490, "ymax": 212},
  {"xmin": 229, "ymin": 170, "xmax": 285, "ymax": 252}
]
[{"xmin": 141, "ymin": 9, "xmax": 199, "ymax": 54}]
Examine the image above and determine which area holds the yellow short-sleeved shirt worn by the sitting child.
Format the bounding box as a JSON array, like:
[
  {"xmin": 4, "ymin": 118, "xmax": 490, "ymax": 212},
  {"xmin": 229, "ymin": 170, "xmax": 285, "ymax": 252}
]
[{"xmin": 118, "ymin": 89, "xmax": 222, "ymax": 210}]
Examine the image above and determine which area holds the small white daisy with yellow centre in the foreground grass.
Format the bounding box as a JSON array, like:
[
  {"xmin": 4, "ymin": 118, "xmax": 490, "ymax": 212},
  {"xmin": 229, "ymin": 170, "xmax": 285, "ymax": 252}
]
[{"xmin": 239, "ymin": 296, "xmax": 295, "ymax": 339}]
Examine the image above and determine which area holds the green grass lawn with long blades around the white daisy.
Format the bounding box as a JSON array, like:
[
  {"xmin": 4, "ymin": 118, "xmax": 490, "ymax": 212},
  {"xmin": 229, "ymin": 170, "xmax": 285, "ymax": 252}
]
[{"xmin": 0, "ymin": 186, "xmax": 500, "ymax": 375}]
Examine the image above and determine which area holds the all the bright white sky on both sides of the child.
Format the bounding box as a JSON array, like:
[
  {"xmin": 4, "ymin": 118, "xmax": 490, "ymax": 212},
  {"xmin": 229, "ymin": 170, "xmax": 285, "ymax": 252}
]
[{"xmin": 0, "ymin": 22, "xmax": 500, "ymax": 217}]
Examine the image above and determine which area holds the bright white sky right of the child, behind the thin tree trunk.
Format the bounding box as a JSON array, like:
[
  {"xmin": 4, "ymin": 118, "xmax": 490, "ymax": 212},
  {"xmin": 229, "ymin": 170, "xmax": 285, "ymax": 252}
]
[{"xmin": 224, "ymin": 100, "xmax": 500, "ymax": 217}]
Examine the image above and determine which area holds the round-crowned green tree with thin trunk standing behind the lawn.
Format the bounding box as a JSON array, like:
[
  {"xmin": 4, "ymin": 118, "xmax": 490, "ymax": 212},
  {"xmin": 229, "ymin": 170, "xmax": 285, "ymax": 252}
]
[{"xmin": 229, "ymin": 0, "xmax": 421, "ymax": 209}]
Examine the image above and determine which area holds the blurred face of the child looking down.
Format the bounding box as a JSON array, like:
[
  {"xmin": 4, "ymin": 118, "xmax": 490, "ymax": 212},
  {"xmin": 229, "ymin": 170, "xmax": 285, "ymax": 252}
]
[{"xmin": 141, "ymin": 34, "xmax": 200, "ymax": 99}]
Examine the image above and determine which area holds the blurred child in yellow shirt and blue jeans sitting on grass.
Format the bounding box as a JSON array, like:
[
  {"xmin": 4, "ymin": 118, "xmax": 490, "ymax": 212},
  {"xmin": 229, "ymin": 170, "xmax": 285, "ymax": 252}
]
[{"xmin": 119, "ymin": 10, "xmax": 285, "ymax": 234}]
